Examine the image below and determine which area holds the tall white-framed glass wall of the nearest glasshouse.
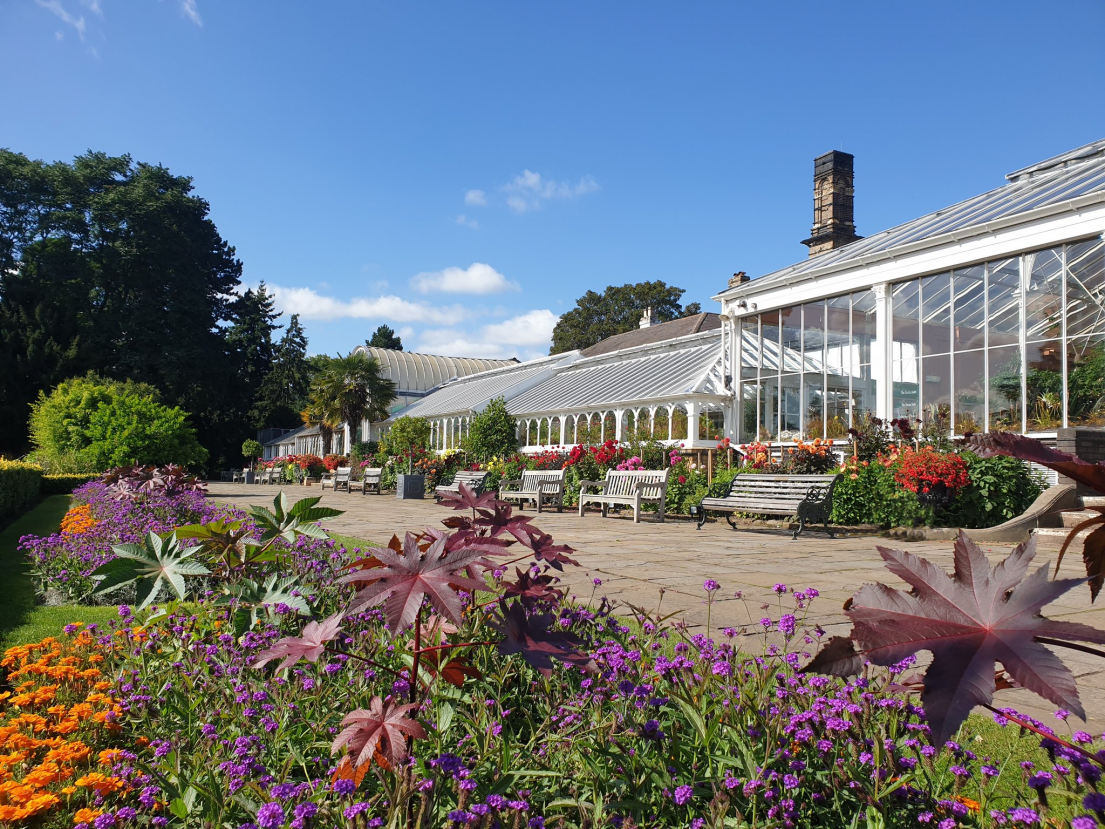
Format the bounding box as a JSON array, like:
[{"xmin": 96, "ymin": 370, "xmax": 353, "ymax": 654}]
[{"xmin": 740, "ymin": 239, "xmax": 1105, "ymax": 441}]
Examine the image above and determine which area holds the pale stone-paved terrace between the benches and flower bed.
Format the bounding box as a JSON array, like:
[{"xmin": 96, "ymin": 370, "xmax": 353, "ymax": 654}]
[{"xmin": 209, "ymin": 483, "xmax": 1105, "ymax": 728}]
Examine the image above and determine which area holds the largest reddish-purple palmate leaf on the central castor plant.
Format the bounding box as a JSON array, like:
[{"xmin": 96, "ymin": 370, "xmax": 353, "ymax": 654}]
[{"xmin": 339, "ymin": 533, "xmax": 486, "ymax": 630}]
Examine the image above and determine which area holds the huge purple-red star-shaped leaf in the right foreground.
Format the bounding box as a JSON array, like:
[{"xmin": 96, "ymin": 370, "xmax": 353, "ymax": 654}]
[{"xmin": 808, "ymin": 532, "xmax": 1105, "ymax": 743}]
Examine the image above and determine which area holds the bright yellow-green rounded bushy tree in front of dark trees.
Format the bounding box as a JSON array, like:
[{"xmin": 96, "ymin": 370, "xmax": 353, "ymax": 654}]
[{"xmin": 31, "ymin": 374, "xmax": 208, "ymax": 472}]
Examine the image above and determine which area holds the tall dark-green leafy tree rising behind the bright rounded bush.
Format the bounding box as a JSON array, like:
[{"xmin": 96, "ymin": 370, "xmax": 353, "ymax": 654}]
[{"xmin": 0, "ymin": 150, "xmax": 243, "ymax": 460}]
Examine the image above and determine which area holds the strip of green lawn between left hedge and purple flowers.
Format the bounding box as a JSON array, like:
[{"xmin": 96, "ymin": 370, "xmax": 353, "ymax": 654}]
[{"xmin": 0, "ymin": 495, "xmax": 116, "ymax": 651}]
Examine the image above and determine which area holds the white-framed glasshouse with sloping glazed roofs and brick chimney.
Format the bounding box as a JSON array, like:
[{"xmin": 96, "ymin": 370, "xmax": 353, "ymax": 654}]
[{"xmin": 375, "ymin": 140, "xmax": 1105, "ymax": 451}]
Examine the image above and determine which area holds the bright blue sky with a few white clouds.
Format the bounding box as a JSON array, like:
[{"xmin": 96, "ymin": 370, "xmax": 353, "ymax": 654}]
[{"xmin": 0, "ymin": 0, "xmax": 1105, "ymax": 357}]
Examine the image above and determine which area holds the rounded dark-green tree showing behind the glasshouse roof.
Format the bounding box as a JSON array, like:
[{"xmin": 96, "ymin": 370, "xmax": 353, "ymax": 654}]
[{"xmin": 549, "ymin": 280, "xmax": 702, "ymax": 354}]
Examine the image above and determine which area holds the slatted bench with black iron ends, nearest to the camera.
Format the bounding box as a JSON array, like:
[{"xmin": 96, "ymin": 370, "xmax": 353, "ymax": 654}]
[{"xmin": 691, "ymin": 473, "xmax": 840, "ymax": 538}]
